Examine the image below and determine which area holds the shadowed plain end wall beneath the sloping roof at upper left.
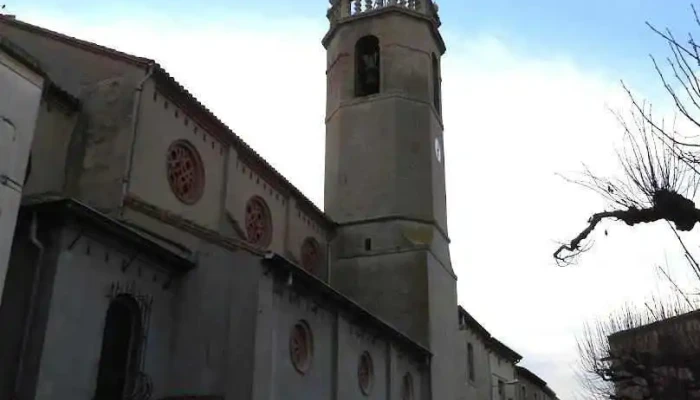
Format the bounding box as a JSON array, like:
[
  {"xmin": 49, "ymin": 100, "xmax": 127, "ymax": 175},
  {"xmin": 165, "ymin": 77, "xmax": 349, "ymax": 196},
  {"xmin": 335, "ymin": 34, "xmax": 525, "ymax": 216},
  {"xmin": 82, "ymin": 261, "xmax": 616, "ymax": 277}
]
[{"xmin": 0, "ymin": 17, "xmax": 146, "ymax": 212}]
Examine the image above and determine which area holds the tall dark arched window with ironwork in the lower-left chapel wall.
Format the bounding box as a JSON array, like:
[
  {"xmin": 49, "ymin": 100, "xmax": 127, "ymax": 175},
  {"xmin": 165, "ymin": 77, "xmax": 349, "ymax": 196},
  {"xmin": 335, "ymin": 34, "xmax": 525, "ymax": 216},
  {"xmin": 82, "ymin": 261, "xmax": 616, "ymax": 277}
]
[{"xmin": 95, "ymin": 295, "xmax": 141, "ymax": 400}]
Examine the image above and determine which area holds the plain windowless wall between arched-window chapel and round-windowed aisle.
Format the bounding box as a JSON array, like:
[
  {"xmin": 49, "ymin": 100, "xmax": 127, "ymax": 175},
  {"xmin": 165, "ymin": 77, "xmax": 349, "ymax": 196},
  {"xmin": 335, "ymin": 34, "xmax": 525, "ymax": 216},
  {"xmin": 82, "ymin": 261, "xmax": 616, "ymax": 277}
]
[{"xmin": 167, "ymin": 244, "xmax": 262, "ymax": 399}]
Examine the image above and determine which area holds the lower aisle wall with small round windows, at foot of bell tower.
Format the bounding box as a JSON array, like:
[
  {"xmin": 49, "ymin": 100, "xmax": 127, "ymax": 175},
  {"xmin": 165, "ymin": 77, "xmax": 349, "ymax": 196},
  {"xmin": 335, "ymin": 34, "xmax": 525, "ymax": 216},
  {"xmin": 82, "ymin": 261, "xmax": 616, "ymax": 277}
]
[{"xmin": 253, "ymin": 258, "xmax": 429, "ymax": 400}]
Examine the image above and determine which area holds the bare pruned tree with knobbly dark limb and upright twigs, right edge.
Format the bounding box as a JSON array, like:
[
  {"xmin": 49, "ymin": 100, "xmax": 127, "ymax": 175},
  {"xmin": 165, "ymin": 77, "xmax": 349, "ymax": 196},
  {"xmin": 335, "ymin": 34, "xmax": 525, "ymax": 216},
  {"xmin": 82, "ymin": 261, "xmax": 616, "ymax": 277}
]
[{"xmin": 554, "ymin": 6, "xmax": 700, "ymax": 268}]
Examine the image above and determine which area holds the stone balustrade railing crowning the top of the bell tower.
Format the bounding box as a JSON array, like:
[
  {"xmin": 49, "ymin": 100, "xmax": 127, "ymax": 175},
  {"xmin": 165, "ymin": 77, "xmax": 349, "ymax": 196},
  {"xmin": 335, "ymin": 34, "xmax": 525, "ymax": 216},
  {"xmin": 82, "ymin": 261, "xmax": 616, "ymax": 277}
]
[{"xmin": 328, "ymin": 0, "xmax": 439, "ymax": 25}]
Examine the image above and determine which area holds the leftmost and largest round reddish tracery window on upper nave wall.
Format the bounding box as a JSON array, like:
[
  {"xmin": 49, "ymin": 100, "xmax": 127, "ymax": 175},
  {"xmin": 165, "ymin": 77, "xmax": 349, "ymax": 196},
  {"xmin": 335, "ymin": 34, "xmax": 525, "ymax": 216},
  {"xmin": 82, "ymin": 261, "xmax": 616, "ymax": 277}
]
[{"xmin": 167, "ymin": 140, "xmax": 204, "ymax": 204}]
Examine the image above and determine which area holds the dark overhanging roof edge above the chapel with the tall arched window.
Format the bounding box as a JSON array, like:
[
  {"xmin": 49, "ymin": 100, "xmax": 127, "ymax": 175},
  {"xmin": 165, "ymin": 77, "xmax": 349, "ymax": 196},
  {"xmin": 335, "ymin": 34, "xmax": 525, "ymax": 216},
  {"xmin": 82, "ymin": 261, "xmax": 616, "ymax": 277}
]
[{"xmin": 20, "ymin": 195, "xmax": 195, "ymax": 273}]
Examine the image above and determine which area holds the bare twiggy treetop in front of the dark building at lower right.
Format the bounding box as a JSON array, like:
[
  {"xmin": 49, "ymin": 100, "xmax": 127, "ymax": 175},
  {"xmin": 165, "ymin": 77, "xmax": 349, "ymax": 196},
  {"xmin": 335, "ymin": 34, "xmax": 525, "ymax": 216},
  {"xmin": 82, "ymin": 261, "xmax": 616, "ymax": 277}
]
[{"xmin": 577, "ymin": 296, "xmax": 700, "ymax": 400}]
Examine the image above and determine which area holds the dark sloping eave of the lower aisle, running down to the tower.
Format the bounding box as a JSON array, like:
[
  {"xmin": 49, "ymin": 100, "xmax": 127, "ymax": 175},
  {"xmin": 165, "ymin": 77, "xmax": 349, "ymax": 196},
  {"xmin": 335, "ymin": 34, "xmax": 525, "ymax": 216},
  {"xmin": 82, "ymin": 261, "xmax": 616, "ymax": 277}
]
[{"xmin": 264, "ymin": 253, "xmax": 432, "ymax": 359}]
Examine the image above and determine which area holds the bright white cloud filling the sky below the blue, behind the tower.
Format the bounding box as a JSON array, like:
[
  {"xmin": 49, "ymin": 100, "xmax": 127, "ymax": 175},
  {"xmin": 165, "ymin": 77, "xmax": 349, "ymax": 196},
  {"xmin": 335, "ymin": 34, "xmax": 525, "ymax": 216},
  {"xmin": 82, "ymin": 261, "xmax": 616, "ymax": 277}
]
[{"xmin": 17, "ymin": 7, "xmax": 700, "ymax": 399}]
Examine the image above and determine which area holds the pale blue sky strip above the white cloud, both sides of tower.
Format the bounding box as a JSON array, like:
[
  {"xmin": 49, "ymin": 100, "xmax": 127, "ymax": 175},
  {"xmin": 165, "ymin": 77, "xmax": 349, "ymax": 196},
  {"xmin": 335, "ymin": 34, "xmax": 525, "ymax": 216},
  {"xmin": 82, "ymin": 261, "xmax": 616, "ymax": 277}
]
[{"xmin": 13, "ymin": 0, "xmax": 694, "ymax": 86}]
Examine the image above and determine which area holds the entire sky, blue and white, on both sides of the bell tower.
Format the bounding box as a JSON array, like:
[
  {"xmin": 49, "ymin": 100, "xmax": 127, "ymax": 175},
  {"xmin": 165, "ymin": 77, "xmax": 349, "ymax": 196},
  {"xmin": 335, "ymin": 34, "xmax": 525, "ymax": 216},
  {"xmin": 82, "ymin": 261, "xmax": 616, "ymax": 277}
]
[{"xmin": 5, "ymin": 0, "xmax": 694, "ymax": 399}]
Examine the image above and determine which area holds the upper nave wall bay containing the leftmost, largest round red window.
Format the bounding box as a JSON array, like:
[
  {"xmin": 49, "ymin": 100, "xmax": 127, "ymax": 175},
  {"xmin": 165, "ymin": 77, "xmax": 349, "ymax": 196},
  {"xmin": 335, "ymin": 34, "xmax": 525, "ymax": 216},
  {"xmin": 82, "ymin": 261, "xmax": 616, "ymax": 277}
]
[{"xmin": 128, "ymin": 80, "xmax": 227, "ymax": 229}]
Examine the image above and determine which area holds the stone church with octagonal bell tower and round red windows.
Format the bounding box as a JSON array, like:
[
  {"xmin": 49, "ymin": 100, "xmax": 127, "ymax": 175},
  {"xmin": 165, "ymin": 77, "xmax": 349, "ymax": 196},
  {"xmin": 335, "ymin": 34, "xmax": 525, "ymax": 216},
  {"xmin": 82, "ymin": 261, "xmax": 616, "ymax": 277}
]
[{"xmin": 0, "ymin": 0, "xmax": 555, "ymax": 400}]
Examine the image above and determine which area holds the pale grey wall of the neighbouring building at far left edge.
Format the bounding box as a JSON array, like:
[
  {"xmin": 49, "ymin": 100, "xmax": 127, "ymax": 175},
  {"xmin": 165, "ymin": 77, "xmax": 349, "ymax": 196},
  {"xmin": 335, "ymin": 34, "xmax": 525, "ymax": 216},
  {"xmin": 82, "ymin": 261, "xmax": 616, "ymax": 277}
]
[{"xmin": 0, "ymin": 50, "xmax": 44, "ymax": 302}]
